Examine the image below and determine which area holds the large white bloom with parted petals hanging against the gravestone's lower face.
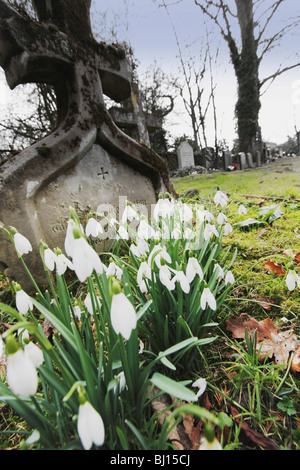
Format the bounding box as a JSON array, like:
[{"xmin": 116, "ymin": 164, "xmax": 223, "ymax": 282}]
[{"xmin": 72, "ymin": 237, "xmax": 103, "ymax": 282}]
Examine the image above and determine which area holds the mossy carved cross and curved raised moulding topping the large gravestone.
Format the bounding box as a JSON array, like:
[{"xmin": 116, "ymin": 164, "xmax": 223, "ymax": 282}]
[{"xmin": 0, "ymin": 0, "xmax": 174, "ymax": 290}]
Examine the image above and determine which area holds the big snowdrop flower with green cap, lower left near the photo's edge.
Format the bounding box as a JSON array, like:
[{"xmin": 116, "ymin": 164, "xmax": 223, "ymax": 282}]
[{"xmin": 6, "ymin": 335, "xmax": 38, "ymax": 397}]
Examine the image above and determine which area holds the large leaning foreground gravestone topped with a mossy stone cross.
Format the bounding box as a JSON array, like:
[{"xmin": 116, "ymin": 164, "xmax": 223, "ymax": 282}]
[{"xmin": 0, "ymin": 0, "xmax": 175, "ymax": 288}]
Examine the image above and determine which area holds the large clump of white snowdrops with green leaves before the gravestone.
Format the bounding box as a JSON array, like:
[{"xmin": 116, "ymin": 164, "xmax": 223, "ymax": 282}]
[{"xmin": 0, "ymin": 191, "xmax": 239, "ymax": 450}]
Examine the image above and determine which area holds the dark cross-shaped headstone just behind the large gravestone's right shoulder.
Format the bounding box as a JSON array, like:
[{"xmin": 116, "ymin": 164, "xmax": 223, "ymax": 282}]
[{"xmin": 109, "ymin": 82, "xmax": 162, "ymax": 147}]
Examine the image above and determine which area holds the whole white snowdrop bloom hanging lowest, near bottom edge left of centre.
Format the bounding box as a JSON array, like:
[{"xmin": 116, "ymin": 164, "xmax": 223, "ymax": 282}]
[{"xmin": 77, "ymin": 401, "xmax": 105, "ymax": 450}]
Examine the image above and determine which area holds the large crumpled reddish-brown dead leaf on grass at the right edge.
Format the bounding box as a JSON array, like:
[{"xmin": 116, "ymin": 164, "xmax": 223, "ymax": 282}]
[{"xmin": 226, "ymin": 313, "xmax": 297, "ymax": 365}]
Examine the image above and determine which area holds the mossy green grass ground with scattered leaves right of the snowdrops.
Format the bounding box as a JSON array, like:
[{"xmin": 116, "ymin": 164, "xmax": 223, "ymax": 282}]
[{"xmin": 0, "ymin": 157, "xmax": 300, "ymax": 450}]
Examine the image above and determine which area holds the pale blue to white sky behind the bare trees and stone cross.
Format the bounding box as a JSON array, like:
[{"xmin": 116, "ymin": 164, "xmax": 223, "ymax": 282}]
[{"xmin": 0, "ymin": 0, "xmax": 300, "ymax": 147}]
